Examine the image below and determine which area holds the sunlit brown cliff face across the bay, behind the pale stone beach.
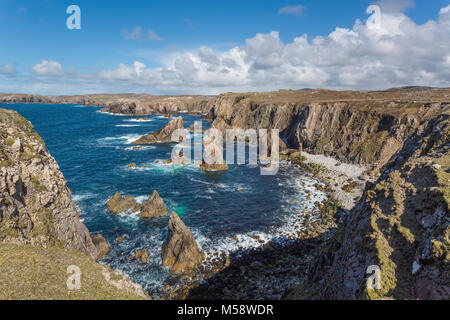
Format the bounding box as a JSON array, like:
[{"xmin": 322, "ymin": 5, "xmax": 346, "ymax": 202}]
[{"xmin": 208, "ymin": 94, "xmax": 450, "ymax": 169}]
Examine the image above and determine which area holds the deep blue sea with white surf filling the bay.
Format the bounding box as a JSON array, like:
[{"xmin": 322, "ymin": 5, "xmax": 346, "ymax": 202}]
[{"xmin": 0, "ymin": 104, "xmax": 325, "ymax": 293}]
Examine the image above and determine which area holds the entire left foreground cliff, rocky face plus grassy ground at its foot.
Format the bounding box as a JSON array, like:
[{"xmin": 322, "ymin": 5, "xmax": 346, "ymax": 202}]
[{"xmin": 0, "ymin": 109, "xmax": 144, "ymax": 299}]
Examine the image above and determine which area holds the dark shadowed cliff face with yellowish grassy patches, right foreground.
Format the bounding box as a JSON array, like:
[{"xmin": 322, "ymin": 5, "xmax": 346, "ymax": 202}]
[{"xmin": 287, "ymin": 110, "xmax": 450, "ymax": 299}]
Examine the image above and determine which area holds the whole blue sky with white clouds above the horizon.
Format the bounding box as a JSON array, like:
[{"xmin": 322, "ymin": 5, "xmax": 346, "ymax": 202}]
[{"xmin": 0, "ymin": 0, "xmax": 450, "ymax": 95}]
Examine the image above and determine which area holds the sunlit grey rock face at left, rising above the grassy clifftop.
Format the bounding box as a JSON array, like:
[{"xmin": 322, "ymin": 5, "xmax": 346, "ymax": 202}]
[{"xmin": 0, "ymin": 109, "xmax": 96, "ymax": 259}]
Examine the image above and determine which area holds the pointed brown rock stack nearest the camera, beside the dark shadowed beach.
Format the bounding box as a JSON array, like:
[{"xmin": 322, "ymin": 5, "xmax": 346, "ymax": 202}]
[{"xmin": 162, "ymin": 212, "xmax": 204, "ymax": 273}]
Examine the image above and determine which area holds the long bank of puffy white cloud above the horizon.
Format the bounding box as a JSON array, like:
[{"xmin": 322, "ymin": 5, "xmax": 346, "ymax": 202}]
[{"xmin": 7, "ymin": 6, "xmax": 450, "ymax": 94}]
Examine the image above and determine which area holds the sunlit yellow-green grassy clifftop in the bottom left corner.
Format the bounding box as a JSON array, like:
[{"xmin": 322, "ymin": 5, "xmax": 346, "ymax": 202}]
[{"xmin": 0, "ymin": 244, "xmax": 143, "ymax": 300}]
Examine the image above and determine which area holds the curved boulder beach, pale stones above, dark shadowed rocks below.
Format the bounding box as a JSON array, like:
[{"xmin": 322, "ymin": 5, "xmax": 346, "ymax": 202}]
[{"xmin": 159, "ymin": 153, "xmax": 365, "ymax": 299}]
